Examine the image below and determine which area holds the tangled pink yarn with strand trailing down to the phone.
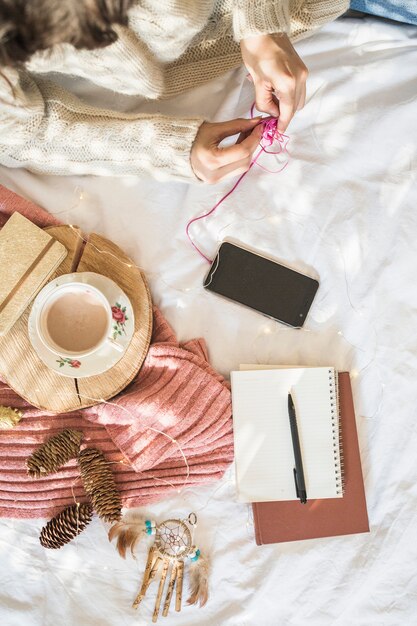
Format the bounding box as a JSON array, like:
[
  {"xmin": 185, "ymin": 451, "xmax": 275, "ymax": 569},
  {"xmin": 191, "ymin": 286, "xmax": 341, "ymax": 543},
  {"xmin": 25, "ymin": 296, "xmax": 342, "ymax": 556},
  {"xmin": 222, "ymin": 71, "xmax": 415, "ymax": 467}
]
[{"xmin": 185, "ymin": 104, "xmax": 289, "ymax": 263}]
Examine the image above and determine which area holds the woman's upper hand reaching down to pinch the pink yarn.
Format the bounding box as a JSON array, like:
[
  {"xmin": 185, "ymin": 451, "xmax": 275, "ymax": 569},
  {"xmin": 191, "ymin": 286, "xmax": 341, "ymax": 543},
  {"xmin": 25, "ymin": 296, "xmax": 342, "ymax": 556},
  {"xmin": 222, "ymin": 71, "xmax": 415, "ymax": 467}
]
[{"xmin": 240, "ymin": 33, "xmax": 308, "ymax": 132}]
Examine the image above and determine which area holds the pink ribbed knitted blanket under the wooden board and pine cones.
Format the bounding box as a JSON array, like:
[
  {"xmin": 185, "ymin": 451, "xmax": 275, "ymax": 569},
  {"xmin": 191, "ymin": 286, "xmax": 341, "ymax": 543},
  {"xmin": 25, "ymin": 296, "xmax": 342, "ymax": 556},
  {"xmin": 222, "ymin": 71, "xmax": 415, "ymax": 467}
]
[{"xmin": 0, "ymin": 185, "xmax": 233, "ymax": 518}]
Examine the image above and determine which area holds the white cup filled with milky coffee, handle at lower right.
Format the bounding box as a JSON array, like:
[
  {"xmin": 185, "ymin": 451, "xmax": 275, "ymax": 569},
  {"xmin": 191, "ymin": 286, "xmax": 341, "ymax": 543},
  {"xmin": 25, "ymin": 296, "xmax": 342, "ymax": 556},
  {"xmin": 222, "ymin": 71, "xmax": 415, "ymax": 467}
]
[{"xmin": 36, "ymin": 281, "xmax": 124, "ymax": 359}]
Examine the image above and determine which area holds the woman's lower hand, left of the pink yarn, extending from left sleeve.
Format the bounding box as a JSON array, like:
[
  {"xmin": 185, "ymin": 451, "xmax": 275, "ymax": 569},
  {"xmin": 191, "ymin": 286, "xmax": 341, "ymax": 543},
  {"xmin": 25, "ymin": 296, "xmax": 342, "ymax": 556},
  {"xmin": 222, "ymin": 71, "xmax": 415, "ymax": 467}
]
[{"xmin": 190, "ymin": 117, "xmax": 262, "ymax": 183}]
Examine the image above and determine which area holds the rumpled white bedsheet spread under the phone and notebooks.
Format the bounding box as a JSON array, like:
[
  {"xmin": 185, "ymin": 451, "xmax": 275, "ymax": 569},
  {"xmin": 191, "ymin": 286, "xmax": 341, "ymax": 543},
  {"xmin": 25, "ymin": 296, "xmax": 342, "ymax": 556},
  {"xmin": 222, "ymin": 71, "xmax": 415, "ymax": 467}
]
[{"xmin": 0, "ymin": 14, "xmax": 417, "ymax": 626}]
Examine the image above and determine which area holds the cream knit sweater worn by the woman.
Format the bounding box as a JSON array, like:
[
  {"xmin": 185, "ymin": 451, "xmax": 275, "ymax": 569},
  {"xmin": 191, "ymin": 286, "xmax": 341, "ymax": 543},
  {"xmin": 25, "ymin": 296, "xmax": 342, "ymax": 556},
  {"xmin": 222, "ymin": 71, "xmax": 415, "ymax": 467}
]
[{"xmin": 0, "ymin": 0, "xmax": 348, "ymax": 180}]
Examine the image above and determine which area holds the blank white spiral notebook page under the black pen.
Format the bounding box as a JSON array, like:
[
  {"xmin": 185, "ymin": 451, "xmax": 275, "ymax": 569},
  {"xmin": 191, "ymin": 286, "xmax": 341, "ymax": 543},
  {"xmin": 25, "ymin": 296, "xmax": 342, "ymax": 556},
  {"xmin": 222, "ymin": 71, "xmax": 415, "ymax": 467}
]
[{"xmin": 231, "ymin": 367, "xmax": 342, "ymax": 502}]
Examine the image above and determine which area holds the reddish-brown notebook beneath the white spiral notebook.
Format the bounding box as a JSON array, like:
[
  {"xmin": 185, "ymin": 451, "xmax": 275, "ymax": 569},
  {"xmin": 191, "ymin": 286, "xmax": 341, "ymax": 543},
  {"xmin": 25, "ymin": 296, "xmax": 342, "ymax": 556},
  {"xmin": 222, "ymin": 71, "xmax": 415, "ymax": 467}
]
[{"xmin": 252, "ymin": 372, "xmax": 369, "ymax": 545}]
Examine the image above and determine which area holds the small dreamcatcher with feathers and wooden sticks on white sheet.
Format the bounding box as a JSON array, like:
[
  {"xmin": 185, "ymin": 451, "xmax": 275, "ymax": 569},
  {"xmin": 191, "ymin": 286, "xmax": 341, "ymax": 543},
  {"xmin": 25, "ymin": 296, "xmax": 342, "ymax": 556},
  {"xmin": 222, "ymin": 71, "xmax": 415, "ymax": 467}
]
[{"xmin": 109, "ymin": 513, "xmax": 208, "ymax": 622}]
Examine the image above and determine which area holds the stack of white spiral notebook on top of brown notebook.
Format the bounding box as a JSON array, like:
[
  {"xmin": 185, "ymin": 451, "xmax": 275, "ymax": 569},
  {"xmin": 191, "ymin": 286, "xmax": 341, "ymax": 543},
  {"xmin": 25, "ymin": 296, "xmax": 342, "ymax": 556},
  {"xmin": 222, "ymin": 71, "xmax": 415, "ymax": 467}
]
[{"xmin": 231, "ymin": 365, "xmax": 369, "ymax": 545}]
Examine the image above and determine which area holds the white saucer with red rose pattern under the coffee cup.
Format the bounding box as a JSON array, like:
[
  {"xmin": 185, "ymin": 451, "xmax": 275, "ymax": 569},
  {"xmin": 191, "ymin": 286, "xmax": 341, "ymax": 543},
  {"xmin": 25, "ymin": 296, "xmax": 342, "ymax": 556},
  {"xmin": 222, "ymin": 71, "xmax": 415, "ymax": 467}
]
[{"xmin": 28, "ymin": 272, "xmax": 135, "ymax": 378}]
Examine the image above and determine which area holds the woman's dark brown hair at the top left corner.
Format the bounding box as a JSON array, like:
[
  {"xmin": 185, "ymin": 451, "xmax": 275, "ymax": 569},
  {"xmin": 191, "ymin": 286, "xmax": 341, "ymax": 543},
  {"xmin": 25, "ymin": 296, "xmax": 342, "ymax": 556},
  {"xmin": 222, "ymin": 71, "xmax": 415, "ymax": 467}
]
[{"xmin": 0, "ymin": 0, "xmax": 134, "ymax": 68}]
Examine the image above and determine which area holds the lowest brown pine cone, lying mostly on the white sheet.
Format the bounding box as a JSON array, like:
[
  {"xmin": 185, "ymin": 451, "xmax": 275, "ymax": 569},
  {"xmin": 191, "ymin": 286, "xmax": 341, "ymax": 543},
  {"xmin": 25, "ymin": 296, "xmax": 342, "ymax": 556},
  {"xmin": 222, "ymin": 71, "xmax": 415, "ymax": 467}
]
[{"xmin": 39, "ymin": 504, "xmax": 93, "ymax": 548}]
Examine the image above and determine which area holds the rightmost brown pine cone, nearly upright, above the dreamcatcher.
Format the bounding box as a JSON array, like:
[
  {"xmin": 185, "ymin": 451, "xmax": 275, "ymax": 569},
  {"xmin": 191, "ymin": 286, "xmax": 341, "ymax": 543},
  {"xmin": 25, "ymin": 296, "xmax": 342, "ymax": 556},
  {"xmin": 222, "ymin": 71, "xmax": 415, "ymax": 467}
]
[{"xmin": 78, "ymin": 448, "xmax": 122, "ymax": 522}]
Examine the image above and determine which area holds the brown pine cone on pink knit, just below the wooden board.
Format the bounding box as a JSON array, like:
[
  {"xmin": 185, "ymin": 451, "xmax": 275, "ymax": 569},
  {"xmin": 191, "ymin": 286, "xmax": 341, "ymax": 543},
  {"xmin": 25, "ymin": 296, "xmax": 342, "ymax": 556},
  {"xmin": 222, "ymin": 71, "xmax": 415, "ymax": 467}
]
[{"xmin": 26, "ymin": 428, "xmax": 83, "ymax": 478}]
